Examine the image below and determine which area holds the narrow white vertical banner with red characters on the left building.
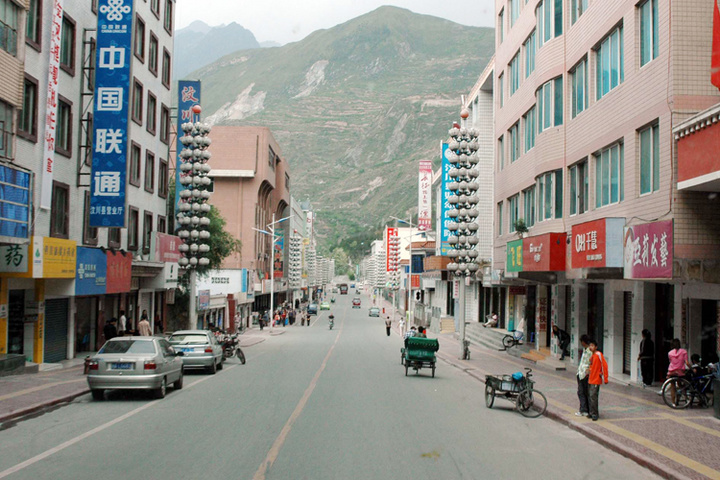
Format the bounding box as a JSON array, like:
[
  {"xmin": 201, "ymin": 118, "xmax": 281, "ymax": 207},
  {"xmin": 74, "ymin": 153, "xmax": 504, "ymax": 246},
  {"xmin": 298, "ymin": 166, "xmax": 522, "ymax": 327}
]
[{"xmin": 40, "ymin": 0, "xmax": 63, "ymax": 210}]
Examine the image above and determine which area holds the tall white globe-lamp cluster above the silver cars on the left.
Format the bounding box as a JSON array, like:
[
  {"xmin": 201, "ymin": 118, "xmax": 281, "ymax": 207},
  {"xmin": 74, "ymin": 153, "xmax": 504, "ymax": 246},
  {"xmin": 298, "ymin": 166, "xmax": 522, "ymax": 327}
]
[{"xmin": 177, "ymin": 105, "xmax": 212, "ymax": 268}]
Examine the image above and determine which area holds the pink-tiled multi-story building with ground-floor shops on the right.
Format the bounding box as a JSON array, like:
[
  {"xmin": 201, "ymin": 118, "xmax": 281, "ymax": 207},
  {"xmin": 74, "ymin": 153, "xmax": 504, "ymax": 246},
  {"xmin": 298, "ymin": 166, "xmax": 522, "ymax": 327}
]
[{"xmin": 493, "ymin": 0, "xmax": 720, "ymax": 378}]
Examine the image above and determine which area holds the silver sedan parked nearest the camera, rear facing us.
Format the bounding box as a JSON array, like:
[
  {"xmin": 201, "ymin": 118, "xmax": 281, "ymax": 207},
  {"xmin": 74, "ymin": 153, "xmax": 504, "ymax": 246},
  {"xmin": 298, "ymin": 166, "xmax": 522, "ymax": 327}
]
[{"xmin": 87, "ymin": 337, "xmax": 184, "ymax": 400}]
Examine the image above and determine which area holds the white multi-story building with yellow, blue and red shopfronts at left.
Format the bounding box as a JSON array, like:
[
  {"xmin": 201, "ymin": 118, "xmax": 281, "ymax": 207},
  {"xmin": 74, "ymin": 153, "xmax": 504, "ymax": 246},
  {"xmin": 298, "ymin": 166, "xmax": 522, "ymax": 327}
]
[{"xmin": 0, "ymin": 0, "xmax": 179, "ymax": 363}]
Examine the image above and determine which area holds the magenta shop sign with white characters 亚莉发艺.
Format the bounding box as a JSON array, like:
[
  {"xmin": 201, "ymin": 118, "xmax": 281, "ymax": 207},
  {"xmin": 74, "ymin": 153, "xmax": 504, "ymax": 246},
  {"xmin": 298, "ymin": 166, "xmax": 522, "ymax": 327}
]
[{"xmin": 623, "ymin": 220, "xmax": 673, "ymax": 279}]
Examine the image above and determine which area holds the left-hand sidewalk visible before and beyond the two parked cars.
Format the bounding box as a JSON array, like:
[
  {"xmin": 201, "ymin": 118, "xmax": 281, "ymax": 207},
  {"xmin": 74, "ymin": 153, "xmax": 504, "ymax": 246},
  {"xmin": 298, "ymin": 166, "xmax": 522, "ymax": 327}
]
[{"xmin": 0, "ymin": 327, "xmax": 276, "ymax": 429}]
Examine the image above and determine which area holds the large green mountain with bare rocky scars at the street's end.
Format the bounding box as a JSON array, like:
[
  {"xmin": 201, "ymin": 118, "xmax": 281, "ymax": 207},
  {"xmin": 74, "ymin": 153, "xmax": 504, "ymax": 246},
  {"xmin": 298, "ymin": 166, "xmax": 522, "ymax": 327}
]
[{"xmin": 193, "ymin": 7, "xmax": 494, "ymax": 253}]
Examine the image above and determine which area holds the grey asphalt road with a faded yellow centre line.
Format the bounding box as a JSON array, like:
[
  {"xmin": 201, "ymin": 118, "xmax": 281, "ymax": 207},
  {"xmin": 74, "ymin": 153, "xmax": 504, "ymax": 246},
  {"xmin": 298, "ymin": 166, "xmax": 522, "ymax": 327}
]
[{"xmin": 0, "ymin": 295, "xmax": 657, "ymax": 480}]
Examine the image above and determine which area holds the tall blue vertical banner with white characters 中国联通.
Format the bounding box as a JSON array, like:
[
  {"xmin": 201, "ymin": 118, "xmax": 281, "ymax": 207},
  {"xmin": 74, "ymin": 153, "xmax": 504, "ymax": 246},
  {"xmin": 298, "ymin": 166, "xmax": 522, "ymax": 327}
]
[{"xmin": 90, "ymin": 0, "xmax": 133, "ymax": 227}]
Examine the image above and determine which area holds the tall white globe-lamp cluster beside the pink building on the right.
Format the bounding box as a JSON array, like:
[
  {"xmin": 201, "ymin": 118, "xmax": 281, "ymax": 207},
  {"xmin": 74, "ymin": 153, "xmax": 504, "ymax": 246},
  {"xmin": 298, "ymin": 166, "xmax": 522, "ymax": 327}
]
[{"xmin": 447, "ymin": 108, "xmax": 480, "ymax": 277}]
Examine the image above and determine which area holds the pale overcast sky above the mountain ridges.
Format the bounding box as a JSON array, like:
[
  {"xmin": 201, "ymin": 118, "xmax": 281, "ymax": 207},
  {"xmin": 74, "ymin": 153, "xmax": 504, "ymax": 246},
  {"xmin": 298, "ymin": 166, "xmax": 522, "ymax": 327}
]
[{"xmin": 176, "ymin": 0, "xmax": 495, "ymax": 44}]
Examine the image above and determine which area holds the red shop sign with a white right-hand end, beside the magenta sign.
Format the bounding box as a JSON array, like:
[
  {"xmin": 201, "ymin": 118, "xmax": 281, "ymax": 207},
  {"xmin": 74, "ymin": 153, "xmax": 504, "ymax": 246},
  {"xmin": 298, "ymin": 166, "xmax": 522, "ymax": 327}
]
[{"xmin": 570, "ymin": 218, "xmax": 625, "ymax": 268}]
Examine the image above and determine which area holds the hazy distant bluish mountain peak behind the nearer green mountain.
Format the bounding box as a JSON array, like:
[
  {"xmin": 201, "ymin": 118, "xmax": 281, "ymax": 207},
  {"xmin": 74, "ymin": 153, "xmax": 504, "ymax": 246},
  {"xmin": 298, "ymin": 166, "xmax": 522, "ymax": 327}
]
[{"xmin": 173, "ymin": 20, "xmax": 260, "ymax": 79}]
